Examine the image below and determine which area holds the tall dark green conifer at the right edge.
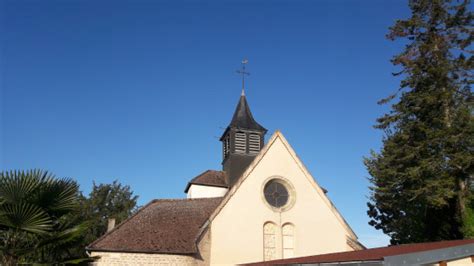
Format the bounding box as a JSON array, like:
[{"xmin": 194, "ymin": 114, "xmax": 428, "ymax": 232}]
[{"xmin": 364, "ymin": 0, "xmax": 474, "ymax": 244}]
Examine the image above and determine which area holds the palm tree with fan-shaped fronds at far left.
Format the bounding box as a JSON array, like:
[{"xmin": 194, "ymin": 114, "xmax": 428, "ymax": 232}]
[{"xmin": 0, "ymin": 170, "xmax": 90, "ymax": 265}]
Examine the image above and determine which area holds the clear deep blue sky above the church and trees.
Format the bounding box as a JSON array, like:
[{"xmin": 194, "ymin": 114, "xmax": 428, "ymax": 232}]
[{"xmin": 0, "ymin": 0, "xmax": 409, "ymax": 246}]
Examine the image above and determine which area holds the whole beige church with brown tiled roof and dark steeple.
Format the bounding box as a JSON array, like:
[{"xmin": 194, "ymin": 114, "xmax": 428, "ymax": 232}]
[{"xmin": 87, "ymin": 69, "xmax": 364, "ymax": 265}]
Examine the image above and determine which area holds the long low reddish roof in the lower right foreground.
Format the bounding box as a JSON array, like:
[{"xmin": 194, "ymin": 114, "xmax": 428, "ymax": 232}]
[{"xmin": 246, "ymin": 239, "xmax": 474, "ymax": 265}]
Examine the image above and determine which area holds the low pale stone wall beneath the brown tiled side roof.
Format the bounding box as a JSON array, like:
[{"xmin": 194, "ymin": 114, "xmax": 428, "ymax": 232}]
[{"xmin": 91, "ymin": 252, "xmax": 197, "ymax": 266}]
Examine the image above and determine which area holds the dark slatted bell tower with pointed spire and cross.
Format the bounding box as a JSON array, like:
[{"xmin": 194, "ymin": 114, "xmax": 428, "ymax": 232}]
[{"xmin": 220, "ymin": 60, "xmax": 267, "ymax": 186}]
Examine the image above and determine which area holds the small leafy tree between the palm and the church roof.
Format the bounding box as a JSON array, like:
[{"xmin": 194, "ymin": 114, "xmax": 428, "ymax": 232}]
[{"xmin": 79, "ymin": 180, "xmax": 138, "ymax": 247}]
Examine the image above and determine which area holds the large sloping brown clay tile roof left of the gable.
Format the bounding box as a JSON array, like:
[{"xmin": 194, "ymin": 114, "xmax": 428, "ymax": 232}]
[{"xmin": 87, "ymin": 198, "xmax": 222, "ymax": 254}]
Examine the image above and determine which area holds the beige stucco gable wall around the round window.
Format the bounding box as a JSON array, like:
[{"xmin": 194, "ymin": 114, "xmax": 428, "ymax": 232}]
[{"xmin": 211, "ymin": 133, "xmax": 358, "ymax": 264}]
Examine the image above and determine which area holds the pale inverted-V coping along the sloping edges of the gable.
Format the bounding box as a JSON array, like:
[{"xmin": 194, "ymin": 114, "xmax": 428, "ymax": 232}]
[{"xmin": 209, "ymin": 130, "xmax": 357, "ymax": 240}]
